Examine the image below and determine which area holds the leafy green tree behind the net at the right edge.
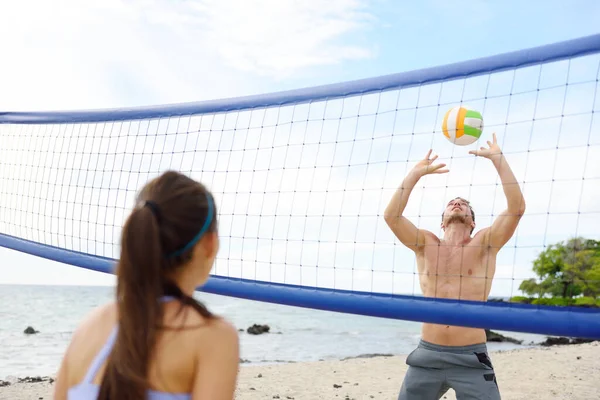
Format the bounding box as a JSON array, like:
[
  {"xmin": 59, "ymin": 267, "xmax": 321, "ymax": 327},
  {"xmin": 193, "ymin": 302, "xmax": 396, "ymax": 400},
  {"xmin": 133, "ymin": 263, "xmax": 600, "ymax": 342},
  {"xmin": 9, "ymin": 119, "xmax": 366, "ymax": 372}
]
[{"xmin": 519, "ymin": 237, "xmax": 600, "ymax": 299}]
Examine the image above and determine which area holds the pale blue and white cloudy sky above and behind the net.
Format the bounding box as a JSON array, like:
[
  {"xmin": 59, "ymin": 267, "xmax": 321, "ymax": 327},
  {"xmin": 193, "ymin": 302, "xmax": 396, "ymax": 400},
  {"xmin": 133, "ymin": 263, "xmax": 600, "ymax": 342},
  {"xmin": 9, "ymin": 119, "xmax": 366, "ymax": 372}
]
[{"xmin": 0, "ymin": 0, "xmax": 600, "ymax": 295}]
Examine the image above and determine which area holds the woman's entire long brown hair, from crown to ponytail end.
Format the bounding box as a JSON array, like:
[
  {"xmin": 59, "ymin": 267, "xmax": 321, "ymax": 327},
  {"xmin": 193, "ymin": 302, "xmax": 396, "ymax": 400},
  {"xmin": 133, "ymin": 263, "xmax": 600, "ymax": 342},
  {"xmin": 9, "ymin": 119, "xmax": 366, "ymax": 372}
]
[{"xmin": 98, "ymin": 171, "xmax": 217, "ymax": 400}]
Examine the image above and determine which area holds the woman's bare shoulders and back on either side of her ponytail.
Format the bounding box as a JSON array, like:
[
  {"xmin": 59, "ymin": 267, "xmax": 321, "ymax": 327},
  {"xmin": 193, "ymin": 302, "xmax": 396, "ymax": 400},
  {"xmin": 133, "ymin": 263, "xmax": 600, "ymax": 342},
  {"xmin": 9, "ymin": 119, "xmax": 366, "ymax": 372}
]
[{"xmin": 57, "ymin": 298, "xmax": 239, "ymax": 400}]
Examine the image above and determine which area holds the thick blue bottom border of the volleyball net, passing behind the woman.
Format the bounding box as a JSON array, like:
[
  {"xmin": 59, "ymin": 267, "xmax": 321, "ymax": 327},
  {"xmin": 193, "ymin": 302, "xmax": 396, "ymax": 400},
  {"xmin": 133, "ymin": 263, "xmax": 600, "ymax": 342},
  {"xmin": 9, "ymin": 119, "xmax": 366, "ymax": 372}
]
[{"xmin": 0, "ymin": 234, "xmax": 600, "ymax": 339}]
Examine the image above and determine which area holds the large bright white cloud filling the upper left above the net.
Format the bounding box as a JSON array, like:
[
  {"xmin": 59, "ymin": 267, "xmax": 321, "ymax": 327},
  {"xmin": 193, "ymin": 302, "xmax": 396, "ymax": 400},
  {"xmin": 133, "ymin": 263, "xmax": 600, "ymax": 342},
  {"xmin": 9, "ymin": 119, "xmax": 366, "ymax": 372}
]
[{"xmin": 0, "ymin": 0, "xmax": 372, "ymax": 111}]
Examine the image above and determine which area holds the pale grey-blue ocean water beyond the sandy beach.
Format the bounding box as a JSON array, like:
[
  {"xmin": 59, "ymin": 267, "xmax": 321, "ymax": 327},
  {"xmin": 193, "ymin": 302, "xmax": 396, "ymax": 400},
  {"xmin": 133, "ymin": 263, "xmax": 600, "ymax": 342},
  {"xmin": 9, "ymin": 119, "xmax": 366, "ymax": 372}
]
[{"xmin": 0, "ymin": 285, "xmax": 544, "ymax": 379}]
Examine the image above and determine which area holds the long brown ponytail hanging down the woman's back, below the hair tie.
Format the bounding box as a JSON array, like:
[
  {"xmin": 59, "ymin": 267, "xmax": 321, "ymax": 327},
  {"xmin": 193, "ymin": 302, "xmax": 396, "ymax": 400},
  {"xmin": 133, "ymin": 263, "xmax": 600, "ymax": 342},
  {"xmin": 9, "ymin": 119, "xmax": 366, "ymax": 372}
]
[{"xmin": 98, "ymin": 206, "xmax": 162, "ymax": 400}]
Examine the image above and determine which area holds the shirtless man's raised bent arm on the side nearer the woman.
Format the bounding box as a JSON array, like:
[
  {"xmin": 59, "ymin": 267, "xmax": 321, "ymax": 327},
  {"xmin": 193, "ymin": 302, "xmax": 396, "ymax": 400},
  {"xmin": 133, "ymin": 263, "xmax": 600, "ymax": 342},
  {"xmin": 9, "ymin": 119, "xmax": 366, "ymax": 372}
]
[{"xmin": 383, "ymin": 150, "xmax": 448, "ymax": 251}]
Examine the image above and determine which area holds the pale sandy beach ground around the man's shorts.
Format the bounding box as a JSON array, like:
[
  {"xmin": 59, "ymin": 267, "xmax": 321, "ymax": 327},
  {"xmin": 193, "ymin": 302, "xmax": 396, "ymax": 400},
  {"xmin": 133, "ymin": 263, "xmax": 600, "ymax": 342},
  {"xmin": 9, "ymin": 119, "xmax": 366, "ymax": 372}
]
[{"xmin": 0, "ymin": 342, "xmax": 600, "ymax": 400}]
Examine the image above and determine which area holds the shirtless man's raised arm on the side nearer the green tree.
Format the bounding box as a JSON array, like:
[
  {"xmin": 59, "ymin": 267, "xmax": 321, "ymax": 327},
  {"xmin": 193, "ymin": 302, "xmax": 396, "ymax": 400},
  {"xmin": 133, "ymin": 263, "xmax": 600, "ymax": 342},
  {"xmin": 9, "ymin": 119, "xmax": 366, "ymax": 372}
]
[{"xmin": 469, "ymin": 133, "xmax": 525, "ymax": 251}]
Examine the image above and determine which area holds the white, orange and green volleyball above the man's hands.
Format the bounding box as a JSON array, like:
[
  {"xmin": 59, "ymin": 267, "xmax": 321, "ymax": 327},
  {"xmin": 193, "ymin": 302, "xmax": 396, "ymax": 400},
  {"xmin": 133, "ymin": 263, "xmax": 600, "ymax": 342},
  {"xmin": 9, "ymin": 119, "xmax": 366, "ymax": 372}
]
[{"xmin": 442, "ymin": 106, "xmax": 483, "ymax": 146}]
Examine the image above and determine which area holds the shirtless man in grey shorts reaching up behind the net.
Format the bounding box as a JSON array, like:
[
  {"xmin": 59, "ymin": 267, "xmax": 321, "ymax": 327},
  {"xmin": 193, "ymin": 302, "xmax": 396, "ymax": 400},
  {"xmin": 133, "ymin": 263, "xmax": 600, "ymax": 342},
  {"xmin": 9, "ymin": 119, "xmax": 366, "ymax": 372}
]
[{"xmin": 385, "ymin": 134, "xmax": 525, "ymax": 400}]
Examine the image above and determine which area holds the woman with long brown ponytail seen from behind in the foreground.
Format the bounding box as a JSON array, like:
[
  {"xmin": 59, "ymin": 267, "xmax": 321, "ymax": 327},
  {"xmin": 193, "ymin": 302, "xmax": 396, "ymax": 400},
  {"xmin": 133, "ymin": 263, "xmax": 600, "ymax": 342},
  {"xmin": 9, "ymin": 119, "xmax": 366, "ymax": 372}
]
[{"xmin": 54, "ymin": 171, "xmax": 239, "ymax": 400}]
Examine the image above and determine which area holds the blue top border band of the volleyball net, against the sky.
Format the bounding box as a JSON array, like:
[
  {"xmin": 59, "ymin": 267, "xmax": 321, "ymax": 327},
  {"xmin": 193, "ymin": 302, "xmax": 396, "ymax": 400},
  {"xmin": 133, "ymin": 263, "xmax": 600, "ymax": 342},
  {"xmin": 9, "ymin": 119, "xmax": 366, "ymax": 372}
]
[{"xmin": 0, "ymin": 34, "xmax": 600, "ymax": 124}]
